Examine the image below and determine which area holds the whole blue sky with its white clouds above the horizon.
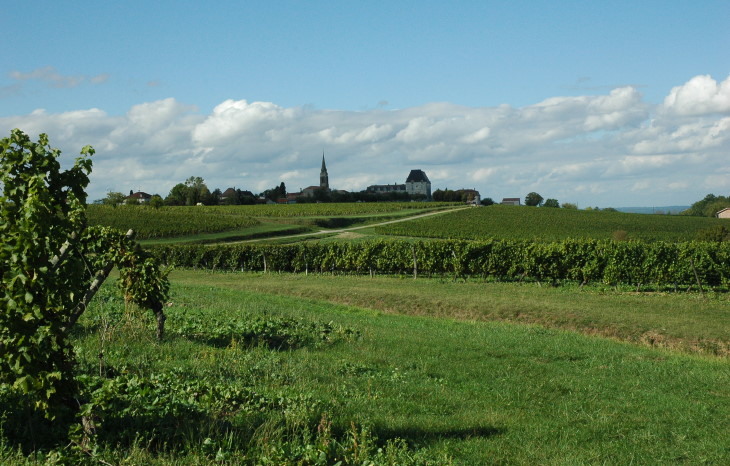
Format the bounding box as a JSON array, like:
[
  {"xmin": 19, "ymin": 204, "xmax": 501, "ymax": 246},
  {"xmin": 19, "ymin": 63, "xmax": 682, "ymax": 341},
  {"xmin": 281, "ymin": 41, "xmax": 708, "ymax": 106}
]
[{"xmin": 0, "ymin": 0, "xmax": 730, "ymax": 208}]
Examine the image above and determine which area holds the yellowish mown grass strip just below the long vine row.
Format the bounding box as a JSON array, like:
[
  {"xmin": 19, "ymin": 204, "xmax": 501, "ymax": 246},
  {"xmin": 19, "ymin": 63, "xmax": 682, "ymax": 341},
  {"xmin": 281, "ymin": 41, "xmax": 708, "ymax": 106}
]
[{"xmin": 173, "ymin": 270, "xmax": 730, "ymax": 356}]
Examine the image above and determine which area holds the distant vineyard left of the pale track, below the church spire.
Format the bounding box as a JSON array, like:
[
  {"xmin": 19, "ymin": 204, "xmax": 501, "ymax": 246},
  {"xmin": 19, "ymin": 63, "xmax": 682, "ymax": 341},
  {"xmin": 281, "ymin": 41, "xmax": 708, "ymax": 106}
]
[{"xmin": 87, "ymin": 202, "xmax": 450, "ymax": 239}]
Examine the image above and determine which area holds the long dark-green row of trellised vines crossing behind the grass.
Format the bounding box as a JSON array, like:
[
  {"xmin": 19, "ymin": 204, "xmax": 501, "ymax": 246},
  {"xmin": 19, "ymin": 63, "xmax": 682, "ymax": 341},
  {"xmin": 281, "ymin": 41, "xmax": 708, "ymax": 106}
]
[{"xmin": 150, "ymin": 240, "xmax": 730, "ymax": 288}]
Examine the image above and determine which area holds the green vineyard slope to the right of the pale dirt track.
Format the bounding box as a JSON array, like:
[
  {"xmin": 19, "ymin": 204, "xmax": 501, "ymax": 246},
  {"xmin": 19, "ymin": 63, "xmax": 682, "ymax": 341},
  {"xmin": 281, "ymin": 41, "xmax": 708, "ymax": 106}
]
[{"xmin": 375, "ymin": 205, "xmax": 727, "ymax": 241}]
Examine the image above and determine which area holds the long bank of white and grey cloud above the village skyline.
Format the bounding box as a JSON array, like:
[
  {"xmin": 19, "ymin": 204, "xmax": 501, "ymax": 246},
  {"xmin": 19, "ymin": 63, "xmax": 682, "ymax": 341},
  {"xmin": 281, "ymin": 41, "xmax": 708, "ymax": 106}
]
[{"xmin": 0, "ymin": 70, "xmax": 730, "ymax": 206}]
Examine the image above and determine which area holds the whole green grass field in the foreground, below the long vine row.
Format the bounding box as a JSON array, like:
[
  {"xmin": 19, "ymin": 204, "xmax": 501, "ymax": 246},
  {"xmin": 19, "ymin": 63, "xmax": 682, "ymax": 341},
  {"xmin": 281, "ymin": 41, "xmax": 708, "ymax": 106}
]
[{"xmin": 48, "ymin": 271, "xmax": 730, "ymax": 464}]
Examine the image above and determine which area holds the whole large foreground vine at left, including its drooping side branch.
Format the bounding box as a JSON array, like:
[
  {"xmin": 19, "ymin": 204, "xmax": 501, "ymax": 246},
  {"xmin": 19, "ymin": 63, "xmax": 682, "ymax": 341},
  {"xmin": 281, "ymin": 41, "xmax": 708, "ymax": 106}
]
[{"xmin": 0, "ymin": 129, "xmax": 169, "ymax": 419}]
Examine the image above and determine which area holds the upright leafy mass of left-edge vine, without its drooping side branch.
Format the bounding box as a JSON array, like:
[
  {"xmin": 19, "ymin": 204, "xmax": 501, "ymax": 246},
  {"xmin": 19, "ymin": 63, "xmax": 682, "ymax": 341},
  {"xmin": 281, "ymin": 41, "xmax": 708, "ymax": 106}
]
[{"xmin": 0, "ymin": 130, "xmax": 94, "ymax": 413}]
